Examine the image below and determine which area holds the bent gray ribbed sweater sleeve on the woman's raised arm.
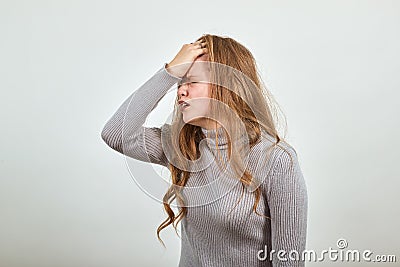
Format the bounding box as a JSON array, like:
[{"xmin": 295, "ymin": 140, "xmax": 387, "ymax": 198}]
[{"xmin": 101, "ymin": 63, "xmax": 180, "ymax": 167}]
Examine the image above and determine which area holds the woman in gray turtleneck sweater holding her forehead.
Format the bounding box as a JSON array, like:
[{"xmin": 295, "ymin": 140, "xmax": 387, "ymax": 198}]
[{"xmin": 102, "ymin": 34, "xmax": 307, "ymax": 267}]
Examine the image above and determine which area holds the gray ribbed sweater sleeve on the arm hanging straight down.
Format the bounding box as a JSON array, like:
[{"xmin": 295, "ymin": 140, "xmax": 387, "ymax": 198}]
[{"xmin": 267, "ymin": 146, "xmax": 308, "ymax": 267}]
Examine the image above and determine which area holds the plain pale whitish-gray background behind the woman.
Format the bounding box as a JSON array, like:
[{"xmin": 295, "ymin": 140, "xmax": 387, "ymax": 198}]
[{"xmin": 0, "ymin": 0, "xmax": 400, "ymax": 267}]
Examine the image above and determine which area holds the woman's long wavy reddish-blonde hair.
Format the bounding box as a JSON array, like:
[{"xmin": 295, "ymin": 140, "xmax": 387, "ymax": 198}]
[{"xmin": 157, "ymin": 34, "xmax": 290, "ymax": 247}]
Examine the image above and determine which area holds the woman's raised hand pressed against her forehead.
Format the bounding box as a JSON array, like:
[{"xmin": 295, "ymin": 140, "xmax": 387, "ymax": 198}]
[{"xmin": 166, "ymin": 40, "xmax": 208, "ymax": 78}]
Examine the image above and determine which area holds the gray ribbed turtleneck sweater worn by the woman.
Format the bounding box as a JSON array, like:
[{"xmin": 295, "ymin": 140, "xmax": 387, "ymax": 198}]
[{"xmin": 101, "ymin": 64, "xmax": 307, "ymax": 267}]
